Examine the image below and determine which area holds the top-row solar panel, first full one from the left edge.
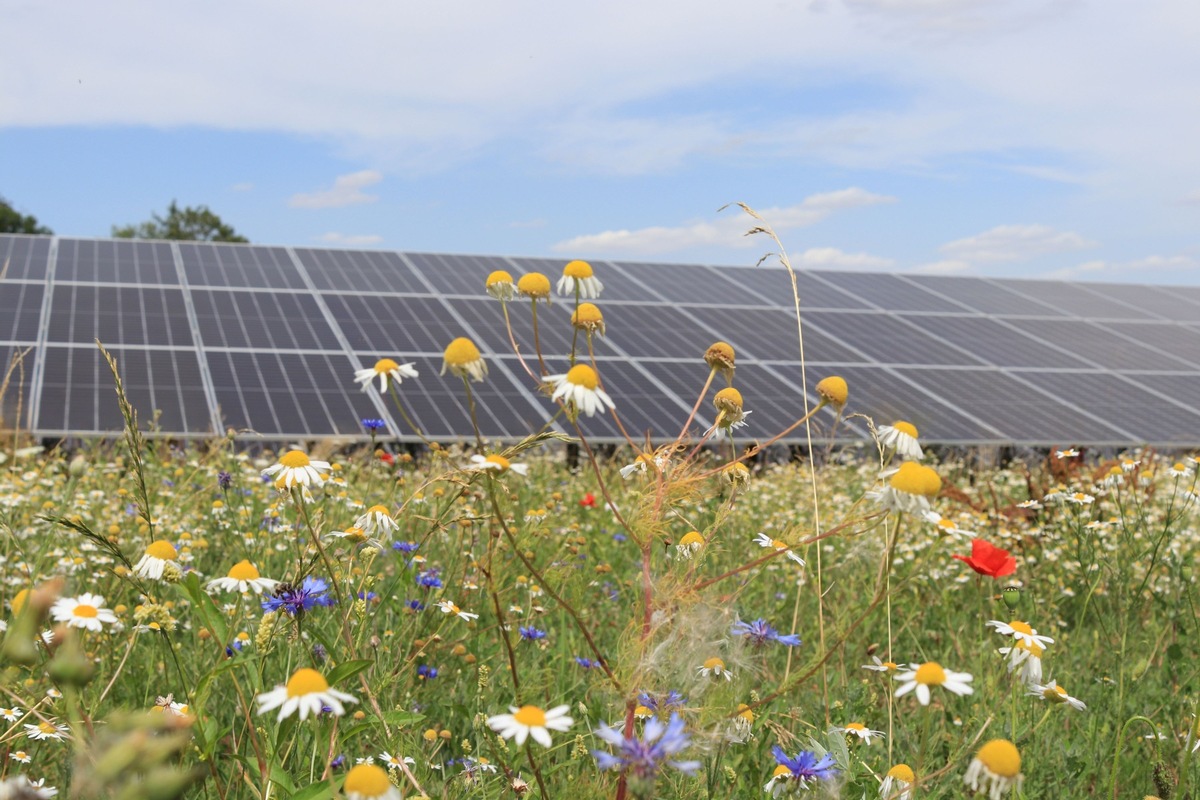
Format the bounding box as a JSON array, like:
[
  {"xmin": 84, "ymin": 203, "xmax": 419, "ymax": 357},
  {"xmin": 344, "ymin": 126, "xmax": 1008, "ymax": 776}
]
[{"xmin": 54, "ymin": 239, "xmax": 179, "ymax": 285}]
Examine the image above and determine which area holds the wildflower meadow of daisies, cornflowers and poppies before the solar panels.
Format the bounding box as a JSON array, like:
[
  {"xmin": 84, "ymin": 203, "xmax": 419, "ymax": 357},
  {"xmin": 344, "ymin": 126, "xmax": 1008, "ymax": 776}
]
[{"xmin": 0, "ymin": 220, "xmax": 1200, "ymax": 800}]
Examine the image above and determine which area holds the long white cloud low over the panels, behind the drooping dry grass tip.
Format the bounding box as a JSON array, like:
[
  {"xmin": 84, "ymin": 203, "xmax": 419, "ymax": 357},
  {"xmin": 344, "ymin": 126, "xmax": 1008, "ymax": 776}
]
[{"xmin": 552, "ymin": 187, "xmax": 896, "ymax": 255}]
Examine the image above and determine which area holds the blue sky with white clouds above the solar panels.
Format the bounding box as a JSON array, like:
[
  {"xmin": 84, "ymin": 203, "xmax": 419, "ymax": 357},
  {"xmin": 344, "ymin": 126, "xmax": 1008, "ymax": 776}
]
[{"xmin": 0, "ymin": 0, "xmax": 1200, "ymax": 284}]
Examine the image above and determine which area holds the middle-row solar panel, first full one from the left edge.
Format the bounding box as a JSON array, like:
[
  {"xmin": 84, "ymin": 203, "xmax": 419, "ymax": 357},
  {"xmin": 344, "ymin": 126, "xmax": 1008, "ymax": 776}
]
[{"xmin": 47, "ymin": 283, "xmax": 192, "ymax": 347}]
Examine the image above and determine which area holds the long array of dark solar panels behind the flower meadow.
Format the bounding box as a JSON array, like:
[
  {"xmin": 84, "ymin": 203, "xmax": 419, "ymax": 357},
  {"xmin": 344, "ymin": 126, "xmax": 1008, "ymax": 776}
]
[{"xmin": 0, "ymin": 235, "xmax": 1200, "ymax": 446}]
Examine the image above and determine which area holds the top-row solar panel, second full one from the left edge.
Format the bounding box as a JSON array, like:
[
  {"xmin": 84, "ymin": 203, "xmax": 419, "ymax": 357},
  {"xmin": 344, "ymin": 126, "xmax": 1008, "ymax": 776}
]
[{"xmin": 179, "ymin": 242, "xmax": 307, "ymax": 289}]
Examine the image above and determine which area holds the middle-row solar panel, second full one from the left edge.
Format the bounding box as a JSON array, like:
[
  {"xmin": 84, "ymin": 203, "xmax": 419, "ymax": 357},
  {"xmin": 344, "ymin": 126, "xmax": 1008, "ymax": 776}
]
[{"xmin": 192, "ymin": 288, "xmax": 342, "ymax": 351}]
